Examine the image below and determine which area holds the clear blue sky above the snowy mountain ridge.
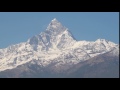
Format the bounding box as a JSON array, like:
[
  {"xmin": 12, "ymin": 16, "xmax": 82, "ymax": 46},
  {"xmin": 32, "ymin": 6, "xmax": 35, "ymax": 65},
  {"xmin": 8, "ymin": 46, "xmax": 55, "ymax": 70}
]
[{"xmin": 0, "ymin": 12, "xmax": 119, "ymax": 48}]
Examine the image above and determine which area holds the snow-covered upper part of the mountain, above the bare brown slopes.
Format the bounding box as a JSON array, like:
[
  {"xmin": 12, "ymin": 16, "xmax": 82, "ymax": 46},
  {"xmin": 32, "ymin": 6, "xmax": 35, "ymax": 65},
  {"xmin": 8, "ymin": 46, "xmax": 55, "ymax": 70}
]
[{"xmin": 0, "ymin": 19, "xmax": 119, "ymax": 71}]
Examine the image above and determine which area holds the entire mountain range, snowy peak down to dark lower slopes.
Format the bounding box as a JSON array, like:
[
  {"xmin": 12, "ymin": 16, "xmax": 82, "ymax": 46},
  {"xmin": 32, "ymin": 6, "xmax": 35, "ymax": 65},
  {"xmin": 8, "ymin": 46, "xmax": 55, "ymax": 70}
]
[{"xmin": 0, "ymin": 19, "xmax": 119, "ymax": 78}]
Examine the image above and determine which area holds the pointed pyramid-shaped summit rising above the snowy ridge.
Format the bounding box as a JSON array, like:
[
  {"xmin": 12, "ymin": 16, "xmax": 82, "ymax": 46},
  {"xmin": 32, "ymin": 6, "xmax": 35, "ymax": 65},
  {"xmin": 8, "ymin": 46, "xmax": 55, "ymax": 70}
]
[{"xmin": 28, "ymin": 18, "xmax": 75, "ymax": 50}]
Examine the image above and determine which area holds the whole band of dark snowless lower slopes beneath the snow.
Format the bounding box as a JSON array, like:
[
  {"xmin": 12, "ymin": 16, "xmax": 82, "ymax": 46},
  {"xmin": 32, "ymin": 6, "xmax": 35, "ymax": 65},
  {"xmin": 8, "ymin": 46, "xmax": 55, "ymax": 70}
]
[{"xmin": 0, "ymin": 50, "xmax": 119, "ymax": 78}]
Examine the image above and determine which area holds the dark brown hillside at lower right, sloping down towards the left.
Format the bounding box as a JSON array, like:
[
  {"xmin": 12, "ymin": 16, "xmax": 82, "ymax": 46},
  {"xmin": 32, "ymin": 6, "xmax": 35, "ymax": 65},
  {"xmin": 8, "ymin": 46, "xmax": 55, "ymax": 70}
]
[{"xmin": 64, "ymin": 53, "xmax": 119, "ymax": 78}]
